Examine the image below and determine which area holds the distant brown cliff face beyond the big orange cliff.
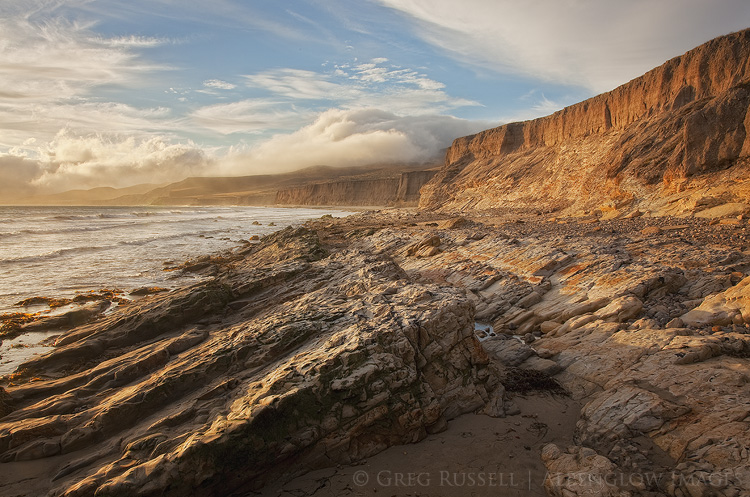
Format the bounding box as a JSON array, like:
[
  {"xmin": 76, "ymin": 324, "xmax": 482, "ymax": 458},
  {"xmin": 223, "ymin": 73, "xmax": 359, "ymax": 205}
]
[{"xmin": 275, "ymin": 170, "xmax": 437, "ymax": 206}]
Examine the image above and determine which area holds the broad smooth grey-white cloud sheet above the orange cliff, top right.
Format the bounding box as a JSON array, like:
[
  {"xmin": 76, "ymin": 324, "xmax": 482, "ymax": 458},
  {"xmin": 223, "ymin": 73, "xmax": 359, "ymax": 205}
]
[{"xmin": 379, "ymin": 0, "xmax": 750, "ymax": 92}]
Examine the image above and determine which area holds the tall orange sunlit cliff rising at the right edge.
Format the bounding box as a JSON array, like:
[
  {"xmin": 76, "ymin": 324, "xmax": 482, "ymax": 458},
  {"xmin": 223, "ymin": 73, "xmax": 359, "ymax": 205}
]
[{"xmin": 420, "ymin": 30, "xmax": 750, "ymax": 215}]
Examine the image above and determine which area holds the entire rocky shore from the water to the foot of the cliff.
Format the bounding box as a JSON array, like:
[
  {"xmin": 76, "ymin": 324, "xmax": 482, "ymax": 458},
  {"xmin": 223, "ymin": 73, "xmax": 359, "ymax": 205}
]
[{"xmin": 0, "ymin": 210, "xmax": 750, "ymax": 496}]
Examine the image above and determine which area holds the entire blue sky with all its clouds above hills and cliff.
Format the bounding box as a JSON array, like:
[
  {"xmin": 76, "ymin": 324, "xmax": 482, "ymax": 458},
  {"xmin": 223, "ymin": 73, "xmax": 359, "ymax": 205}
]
[{"xmin": 0, "ymin": 0, "xmax": 750, "ymax": 198}]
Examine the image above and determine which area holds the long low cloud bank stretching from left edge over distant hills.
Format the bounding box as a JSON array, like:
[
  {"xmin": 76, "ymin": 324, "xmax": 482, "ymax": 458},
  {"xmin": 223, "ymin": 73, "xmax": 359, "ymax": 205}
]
[{"xmin": 0, "ymin": 108, "xmax": 490, "ymax": 200}]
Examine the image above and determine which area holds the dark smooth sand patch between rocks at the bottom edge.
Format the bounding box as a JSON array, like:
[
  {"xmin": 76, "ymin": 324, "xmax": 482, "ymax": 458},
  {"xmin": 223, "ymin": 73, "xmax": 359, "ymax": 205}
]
[{"xmin": 258, "ymin": 394, "xmax": 580, "ymax": 497}]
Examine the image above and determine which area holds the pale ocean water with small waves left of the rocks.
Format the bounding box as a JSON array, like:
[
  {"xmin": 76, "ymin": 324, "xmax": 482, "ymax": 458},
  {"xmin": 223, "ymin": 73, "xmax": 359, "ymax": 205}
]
[{"xmin": 0, "ymin": 207, "xmax": 350, "ymax": 314}]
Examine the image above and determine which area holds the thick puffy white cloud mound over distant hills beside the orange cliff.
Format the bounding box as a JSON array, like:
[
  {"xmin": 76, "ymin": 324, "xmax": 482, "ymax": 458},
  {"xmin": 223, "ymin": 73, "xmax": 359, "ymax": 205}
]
[{"xmin": 221, "ymin": 108, "xmax": 491, "ymax": 174}]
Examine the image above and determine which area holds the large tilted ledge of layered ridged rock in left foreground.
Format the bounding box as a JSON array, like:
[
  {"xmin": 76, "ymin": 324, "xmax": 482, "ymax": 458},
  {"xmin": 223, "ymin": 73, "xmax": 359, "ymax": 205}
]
[{"xmin": 0, "ymin": 228, "xmax": 502, "ymax": 497}]
